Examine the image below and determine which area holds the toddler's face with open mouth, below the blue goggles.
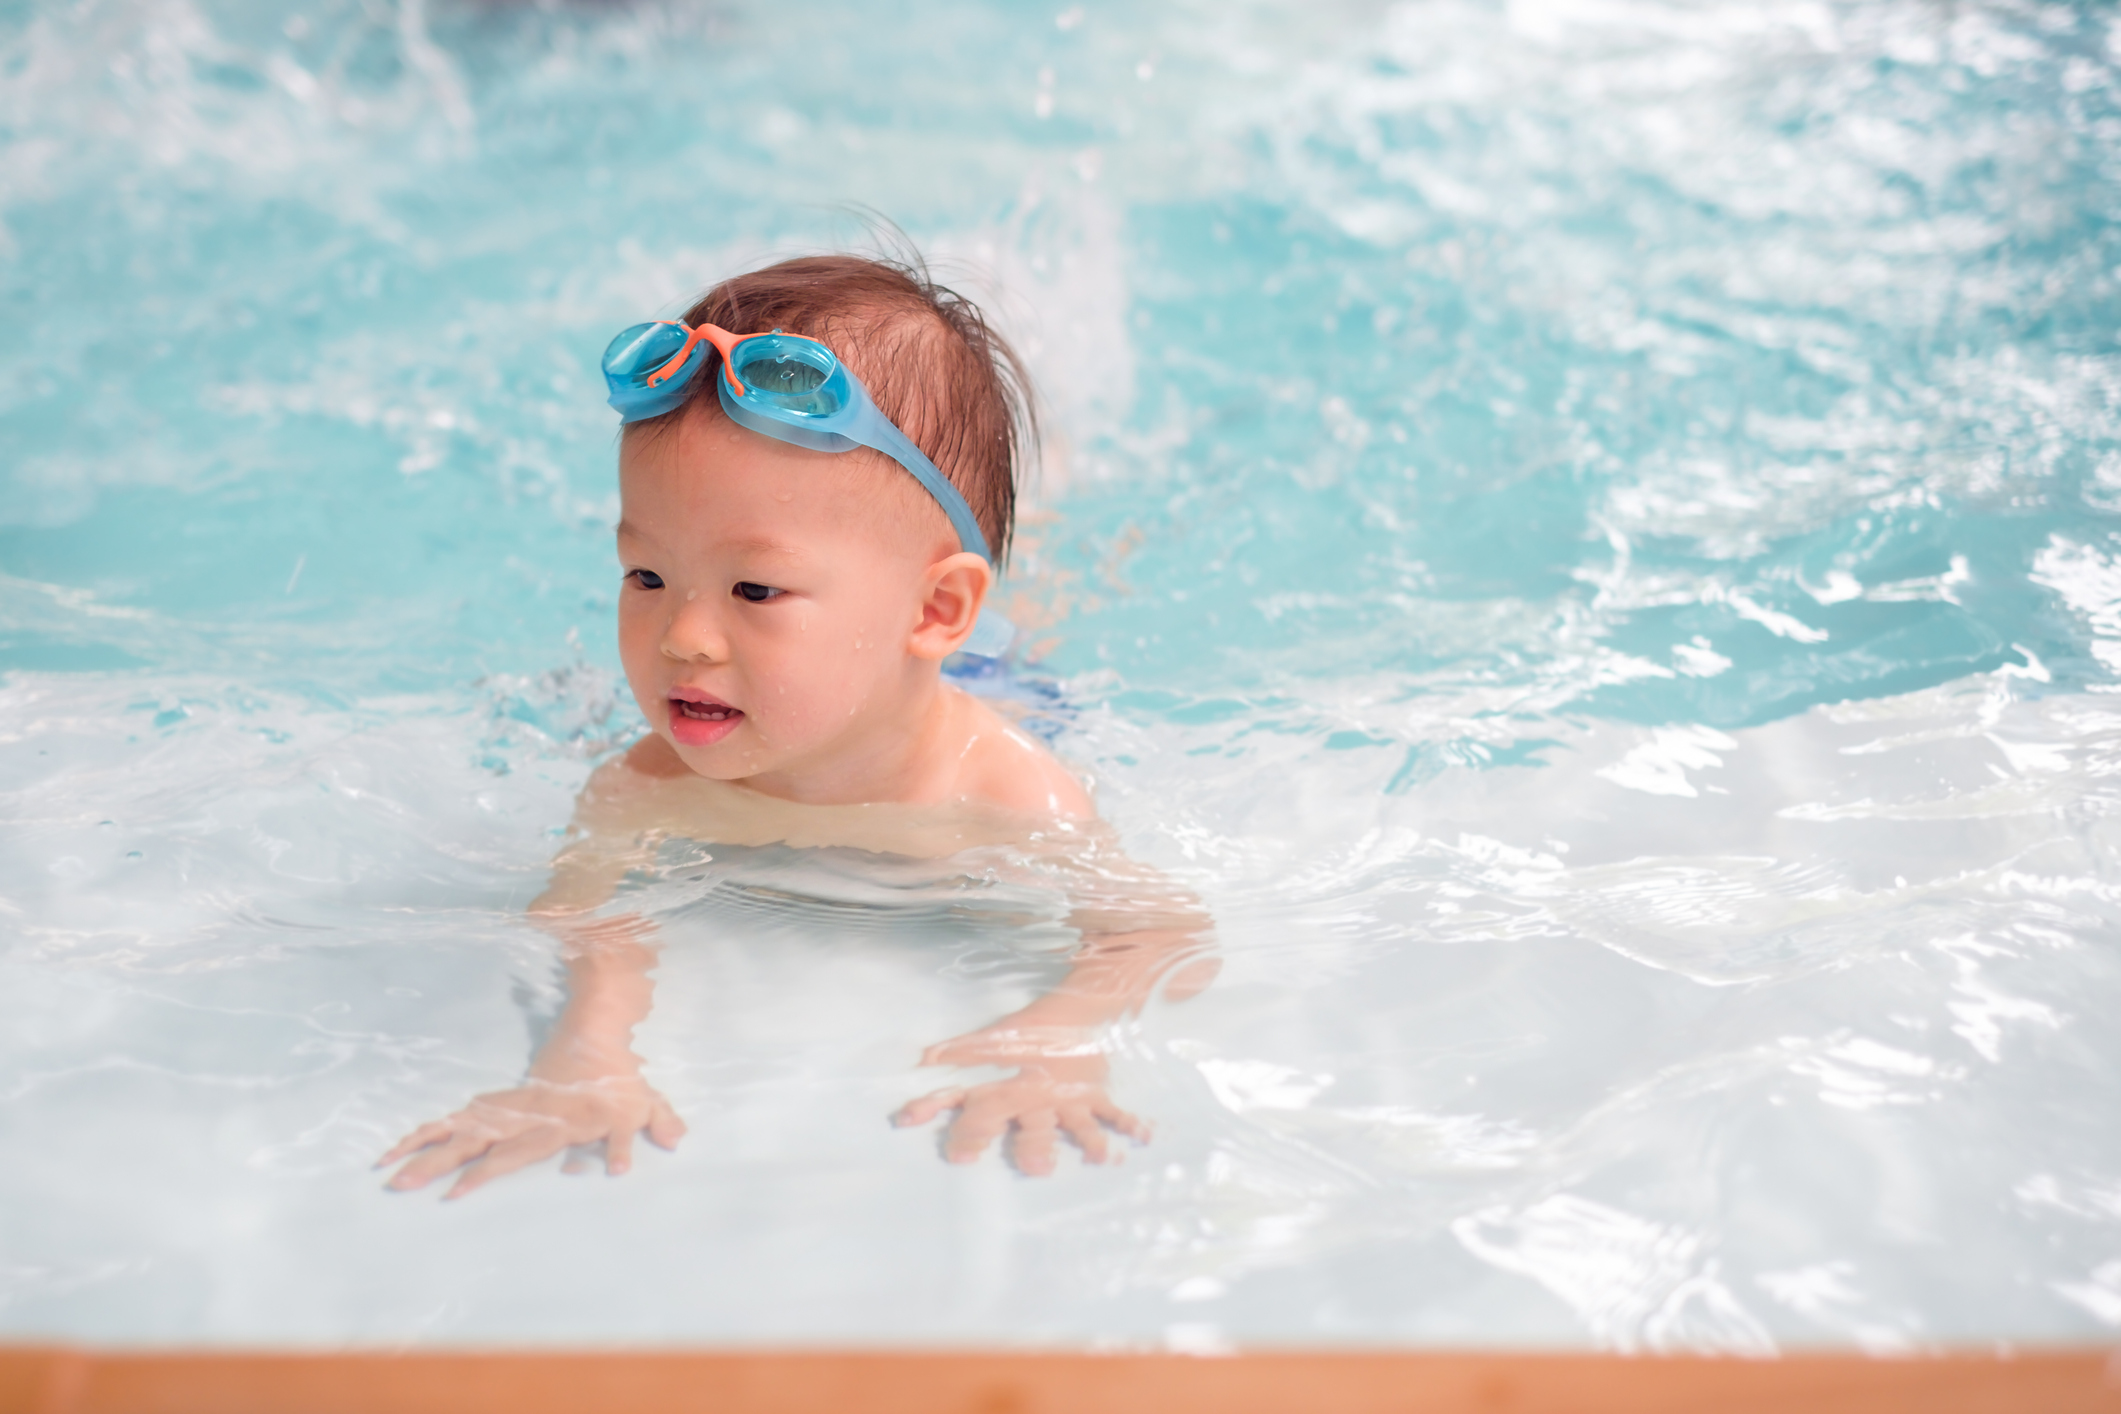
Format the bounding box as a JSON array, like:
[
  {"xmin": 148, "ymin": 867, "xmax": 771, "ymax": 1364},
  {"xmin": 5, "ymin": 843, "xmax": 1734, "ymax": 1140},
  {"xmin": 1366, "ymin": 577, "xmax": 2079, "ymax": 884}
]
[{"xmin": 619, "ymin": 413, "xmax": 957, "ymax": 797}]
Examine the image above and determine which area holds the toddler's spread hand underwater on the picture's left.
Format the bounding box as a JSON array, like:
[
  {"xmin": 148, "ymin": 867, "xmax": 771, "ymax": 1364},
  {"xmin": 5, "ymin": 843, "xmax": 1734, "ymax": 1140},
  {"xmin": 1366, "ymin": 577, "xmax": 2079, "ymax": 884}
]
[{"xmin": 375, "ymin": 1075, "xmax": 685, "ymax": 1198}]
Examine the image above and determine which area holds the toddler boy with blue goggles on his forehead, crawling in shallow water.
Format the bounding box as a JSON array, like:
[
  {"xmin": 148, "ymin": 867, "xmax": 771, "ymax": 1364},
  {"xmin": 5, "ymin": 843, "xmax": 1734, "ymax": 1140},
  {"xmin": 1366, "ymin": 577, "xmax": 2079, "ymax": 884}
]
[{"xmin": 382, "ymin": 257, "xmax": 1213, "ymax": 1198}]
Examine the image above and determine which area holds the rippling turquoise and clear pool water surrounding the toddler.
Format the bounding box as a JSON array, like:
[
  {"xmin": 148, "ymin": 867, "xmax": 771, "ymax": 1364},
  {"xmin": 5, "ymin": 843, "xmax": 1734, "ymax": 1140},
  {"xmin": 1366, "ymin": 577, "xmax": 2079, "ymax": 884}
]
[{"xmin": 0, "ymin": 0, "xmax": 2121, "ymax": 1353}]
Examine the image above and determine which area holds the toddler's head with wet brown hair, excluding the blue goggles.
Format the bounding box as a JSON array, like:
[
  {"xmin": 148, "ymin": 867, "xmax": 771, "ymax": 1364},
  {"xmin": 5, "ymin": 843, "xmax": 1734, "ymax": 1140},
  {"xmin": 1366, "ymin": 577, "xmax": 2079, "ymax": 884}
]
[{"xmin": 619, "ymin": 257, "xmax": 1031, "ymax": 797}]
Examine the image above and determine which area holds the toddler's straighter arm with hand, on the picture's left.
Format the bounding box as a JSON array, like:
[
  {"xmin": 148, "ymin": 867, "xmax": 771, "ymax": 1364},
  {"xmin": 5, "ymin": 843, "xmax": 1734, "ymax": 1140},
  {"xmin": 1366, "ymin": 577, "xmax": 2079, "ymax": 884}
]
[{"xmin": 380, "ymin": 763, "xmax": 685, "ymax": 1198}]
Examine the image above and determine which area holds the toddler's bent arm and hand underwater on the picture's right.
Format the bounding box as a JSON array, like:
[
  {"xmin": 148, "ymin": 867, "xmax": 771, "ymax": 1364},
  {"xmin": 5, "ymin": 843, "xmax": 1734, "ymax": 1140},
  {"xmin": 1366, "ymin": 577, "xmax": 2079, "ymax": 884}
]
[{"xmin": 895, "ymin": 861, "xmax": 1220, "ymax": 1174}]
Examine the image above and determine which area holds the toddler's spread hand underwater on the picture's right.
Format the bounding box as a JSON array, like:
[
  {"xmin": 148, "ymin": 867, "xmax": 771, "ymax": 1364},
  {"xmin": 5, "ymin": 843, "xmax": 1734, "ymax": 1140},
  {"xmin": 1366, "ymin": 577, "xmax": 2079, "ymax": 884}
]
[{"xmin": 891, "ymin": 1055, "xmax": 1150, "ymax": 1177}]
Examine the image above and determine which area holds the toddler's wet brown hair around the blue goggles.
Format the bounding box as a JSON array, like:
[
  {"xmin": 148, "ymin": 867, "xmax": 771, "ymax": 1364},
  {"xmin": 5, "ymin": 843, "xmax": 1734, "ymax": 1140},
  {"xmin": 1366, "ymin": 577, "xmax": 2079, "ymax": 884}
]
[{"xmin": 626, "ymin": 254, "xmax": 1037, "ymax": 566}]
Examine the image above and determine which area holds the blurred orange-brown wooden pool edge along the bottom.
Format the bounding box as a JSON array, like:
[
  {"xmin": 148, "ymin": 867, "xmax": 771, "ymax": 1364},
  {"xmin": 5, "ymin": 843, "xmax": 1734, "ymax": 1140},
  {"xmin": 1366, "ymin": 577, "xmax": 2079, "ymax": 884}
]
[{"xmin": 0, "ymin": 1346, "xmax": 2121, "ymax": 1414}]
